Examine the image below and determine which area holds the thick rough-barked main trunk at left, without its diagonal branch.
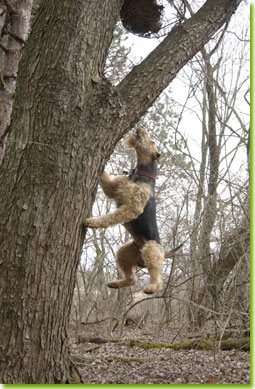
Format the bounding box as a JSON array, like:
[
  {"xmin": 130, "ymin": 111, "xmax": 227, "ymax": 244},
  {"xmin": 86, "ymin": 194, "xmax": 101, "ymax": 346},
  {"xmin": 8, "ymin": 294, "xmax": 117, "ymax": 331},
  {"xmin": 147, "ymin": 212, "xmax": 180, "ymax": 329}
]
[{"xmin": 0, "ymin": 1, "xmax": 123, "ymax": 384}]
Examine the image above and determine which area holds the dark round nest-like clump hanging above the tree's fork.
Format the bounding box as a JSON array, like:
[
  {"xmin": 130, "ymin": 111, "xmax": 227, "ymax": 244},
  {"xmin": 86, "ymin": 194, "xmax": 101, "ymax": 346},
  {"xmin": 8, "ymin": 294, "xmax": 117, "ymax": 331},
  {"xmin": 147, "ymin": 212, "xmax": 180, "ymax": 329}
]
[{"xmin": 120, "ymin": 0, "xmax": 164, "ymax": 36}]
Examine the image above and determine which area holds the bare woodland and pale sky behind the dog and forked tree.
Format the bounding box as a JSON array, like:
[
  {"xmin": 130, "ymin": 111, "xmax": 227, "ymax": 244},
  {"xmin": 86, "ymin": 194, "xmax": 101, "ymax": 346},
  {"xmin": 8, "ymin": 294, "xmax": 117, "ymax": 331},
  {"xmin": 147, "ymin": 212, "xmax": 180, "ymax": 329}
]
[{"xmin": 75, "ymin": 0, "xmax": 250, "ymax": 333}]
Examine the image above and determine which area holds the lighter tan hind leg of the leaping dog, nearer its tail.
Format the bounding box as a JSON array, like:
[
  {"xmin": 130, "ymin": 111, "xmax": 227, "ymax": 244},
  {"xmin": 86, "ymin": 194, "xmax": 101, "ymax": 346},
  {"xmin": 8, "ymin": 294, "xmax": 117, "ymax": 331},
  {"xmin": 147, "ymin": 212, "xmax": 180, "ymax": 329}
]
[{"xmin": 141, "ymin": 240, "xmax": 165, "ymax": 294}]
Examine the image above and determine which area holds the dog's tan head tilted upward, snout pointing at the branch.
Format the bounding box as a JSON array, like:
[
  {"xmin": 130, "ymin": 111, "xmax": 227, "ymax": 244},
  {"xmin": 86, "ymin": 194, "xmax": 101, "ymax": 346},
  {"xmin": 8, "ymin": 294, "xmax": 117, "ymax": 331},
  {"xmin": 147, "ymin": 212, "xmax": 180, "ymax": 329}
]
[{"xmin": 123, "ymin": 128, "xmax": 161, "ymax": 164}]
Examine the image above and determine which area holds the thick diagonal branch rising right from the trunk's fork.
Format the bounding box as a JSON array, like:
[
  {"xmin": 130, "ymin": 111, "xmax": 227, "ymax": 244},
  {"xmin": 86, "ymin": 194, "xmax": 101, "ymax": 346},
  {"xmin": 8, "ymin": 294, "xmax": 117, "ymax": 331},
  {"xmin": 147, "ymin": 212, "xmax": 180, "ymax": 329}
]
[{"xmin": 116, "ymin": 0, "xmax": 242, "ymax": 129}]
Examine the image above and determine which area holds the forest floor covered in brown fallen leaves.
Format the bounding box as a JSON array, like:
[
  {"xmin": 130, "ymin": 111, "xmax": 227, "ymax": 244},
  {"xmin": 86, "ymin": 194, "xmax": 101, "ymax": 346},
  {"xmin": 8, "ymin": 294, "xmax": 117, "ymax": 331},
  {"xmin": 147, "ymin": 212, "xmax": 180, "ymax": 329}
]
[{"xmin": 71, "ymin": 325, "xmax": 250, "ymax": 385}]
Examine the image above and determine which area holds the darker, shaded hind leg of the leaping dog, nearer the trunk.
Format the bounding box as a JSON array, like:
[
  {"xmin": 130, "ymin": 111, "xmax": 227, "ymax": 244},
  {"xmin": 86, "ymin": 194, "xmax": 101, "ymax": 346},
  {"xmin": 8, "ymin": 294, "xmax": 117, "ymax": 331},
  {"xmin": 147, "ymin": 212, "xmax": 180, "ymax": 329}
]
[{"xmin": 107, "ymin": 242, "xmax": 141, "ymax": 288}]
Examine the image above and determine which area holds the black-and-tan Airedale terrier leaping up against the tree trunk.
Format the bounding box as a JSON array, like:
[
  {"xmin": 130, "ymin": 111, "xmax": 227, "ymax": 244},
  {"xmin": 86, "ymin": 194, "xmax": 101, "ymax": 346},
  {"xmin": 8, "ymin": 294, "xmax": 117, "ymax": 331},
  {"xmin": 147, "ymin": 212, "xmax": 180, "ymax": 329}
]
[{"xmin": 85, "ymin": 128, "xmax": 180, "ymax": 294}]
